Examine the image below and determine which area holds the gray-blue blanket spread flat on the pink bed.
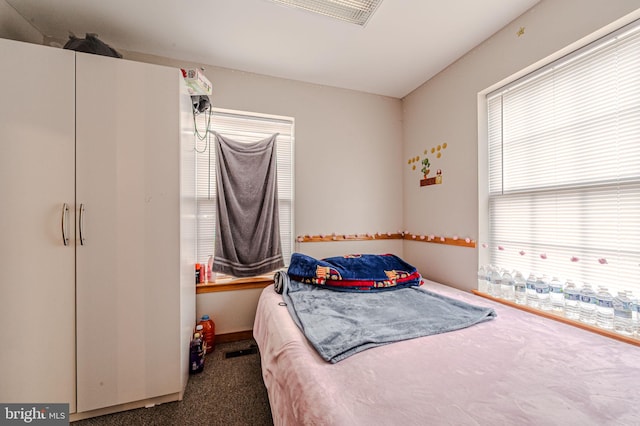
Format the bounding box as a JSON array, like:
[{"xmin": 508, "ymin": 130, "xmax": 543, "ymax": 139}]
[{"xmin": 282, "ymin": 272, "xmax": 497, "ymax": 363}]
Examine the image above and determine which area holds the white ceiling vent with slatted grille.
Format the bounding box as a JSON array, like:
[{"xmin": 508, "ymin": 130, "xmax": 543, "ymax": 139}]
[{"xmin": 271, "ymin": 0, "xmax": 382, "ymax": 27}]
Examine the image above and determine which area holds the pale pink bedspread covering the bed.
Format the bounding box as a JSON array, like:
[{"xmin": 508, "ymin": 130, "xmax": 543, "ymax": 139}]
[{"xmin": 253, "ymin": 281, "xmax": 640, "ymax": 426}]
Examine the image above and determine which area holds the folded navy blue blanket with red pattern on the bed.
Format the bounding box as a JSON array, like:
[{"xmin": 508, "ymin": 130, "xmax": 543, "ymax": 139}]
[{"xmin": 287, "ymin": 253, "xmax": 422, "ymax": 291}]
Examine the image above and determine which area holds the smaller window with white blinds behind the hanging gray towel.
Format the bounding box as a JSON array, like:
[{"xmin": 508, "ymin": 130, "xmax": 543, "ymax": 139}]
[{"xmin": 195, "ymin": 108, "xmax": 294, "ymax": 274}]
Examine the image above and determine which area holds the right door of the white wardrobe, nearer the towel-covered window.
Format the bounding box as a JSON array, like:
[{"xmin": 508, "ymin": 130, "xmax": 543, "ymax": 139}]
[{"xmin": 76, "ymin": 53, "xmax": 180, "ymax": 412}]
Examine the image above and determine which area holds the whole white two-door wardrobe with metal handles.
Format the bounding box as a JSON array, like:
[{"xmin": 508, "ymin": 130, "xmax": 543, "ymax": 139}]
[{"xmin": 0, "ymin": 39, "xmax": 196, "ymax": 420}]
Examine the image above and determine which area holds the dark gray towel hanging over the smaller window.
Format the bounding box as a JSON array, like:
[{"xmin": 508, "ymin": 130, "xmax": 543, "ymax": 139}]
[{"xmin": 212, "ymin": 133, "xmax": 284, "ymax": 277}]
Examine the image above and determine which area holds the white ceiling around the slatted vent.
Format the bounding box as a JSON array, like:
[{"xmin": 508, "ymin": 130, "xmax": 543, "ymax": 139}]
[{"xmin": 6, "ymin": 0, "xmax": 539, "ymax": 98}]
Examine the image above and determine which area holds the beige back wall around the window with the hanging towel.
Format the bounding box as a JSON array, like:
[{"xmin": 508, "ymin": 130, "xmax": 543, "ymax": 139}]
[{"xmin": 122, "ymin": 52, "xmax": 403, "ymax": 333}]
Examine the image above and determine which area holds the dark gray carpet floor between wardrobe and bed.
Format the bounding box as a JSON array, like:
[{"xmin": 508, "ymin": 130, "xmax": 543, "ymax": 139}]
[{"xmin": 72, "ymin": 340, "xmax": 273, "ymax": 426}]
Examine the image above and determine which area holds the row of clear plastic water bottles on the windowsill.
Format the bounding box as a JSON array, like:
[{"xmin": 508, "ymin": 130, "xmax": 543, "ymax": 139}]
[{"xmin": 478, "ymin": 265, "xmax": 640, "ymax": 338}]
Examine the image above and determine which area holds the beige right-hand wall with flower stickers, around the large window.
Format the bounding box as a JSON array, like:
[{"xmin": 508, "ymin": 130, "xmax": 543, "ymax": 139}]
[{"xmin": 403, "ymin": 0, "xmax": 640, "ymax": 289}]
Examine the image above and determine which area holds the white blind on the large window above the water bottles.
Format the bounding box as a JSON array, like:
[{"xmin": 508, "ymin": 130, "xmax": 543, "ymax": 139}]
[{"xmin": 487, "ymin": 22, "xmax": 640, "ymax": 297}]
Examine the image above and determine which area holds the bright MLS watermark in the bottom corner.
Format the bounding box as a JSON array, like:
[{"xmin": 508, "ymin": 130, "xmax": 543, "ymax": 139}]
[{"xmin": 0, "ymin": 403, "xmax": 69, "ymax": 426}]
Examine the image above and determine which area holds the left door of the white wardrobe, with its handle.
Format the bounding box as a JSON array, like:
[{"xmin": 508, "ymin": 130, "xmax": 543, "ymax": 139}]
[{"xmin": 0, "ymin": 39, "xmax": 75, "ymax": 412}]
